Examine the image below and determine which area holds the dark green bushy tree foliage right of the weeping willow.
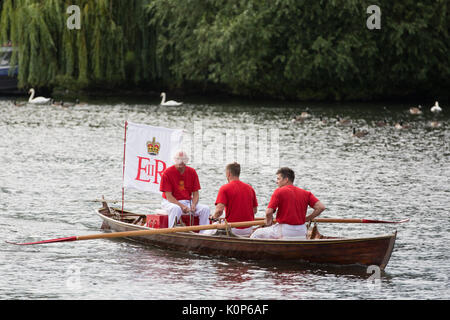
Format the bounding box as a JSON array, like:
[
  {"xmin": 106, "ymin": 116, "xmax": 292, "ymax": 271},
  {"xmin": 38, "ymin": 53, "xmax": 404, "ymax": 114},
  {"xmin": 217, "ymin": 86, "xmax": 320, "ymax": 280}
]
[{"xmin": 150, "ymin": 0, "xmax": 450, "ymax": 99}]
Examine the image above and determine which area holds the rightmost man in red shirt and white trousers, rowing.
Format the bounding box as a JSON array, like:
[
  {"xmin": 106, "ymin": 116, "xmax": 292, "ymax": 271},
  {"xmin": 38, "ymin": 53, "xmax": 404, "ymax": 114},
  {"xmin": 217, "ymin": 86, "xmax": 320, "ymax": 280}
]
[{"xmin": 251, "ymin": 168, "xmax": 326, "ymax": 239}]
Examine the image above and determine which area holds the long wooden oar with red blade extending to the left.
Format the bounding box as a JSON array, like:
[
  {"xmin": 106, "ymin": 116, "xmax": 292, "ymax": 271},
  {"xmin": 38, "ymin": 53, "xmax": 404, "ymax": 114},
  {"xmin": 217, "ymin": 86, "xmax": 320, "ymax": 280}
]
[{"xmin": 7, "ymin": 220, "xmax": 264, "ymax": 246}]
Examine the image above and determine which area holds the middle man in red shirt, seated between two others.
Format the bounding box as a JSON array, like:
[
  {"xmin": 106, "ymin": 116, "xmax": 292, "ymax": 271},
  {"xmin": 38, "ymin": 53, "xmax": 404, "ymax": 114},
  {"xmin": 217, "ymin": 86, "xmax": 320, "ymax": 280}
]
[{"xmin": 212, "ymin": 162, "xmax": 258, "ymax": 236}]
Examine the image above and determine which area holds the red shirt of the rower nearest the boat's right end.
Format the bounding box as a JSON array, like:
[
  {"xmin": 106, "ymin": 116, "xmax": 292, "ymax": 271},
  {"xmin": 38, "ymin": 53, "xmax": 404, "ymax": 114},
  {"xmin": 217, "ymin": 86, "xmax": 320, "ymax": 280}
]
[{"xmin": 268, "ymin": 185, "xmax": 319, "ymax": 225}]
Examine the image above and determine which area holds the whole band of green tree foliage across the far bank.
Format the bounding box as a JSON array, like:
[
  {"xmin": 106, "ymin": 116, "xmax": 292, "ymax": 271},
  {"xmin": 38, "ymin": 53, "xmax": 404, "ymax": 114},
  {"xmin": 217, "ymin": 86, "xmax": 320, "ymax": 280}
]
[{"xmin": 0, "ymin": 0, "xmax": 450, "ymax": 100}]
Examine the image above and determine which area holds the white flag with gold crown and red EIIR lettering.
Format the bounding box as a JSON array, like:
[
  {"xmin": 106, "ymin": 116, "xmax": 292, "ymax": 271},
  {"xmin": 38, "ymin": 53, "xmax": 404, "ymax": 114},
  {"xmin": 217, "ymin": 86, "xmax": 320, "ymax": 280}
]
[{"xmin": 123, "ymin": 122, "xmax": 183, "ymax": 193}]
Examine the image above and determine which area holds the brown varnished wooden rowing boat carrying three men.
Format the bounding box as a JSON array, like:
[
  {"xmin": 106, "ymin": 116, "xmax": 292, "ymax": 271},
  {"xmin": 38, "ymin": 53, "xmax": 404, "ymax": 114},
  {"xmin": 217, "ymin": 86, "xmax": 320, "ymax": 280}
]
[{"xmin": 96, "ymin": 202, "xmax": 397, "ymax": 270}]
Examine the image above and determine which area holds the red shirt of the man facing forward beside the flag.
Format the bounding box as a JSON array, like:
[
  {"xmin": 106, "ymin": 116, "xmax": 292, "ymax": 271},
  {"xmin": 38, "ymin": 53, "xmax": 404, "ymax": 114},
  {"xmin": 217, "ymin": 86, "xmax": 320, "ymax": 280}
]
[{"xmin": 159, "ymin": 166, "xmax": 200, "ymax": 200}]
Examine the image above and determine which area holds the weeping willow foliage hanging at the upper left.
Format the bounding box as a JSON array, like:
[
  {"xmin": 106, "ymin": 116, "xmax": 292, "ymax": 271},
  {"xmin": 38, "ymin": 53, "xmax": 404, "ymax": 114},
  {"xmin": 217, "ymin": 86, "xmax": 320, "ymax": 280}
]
[{"xmin": 0, "ymin": 0, "xmax": 156, "ymax": 88}]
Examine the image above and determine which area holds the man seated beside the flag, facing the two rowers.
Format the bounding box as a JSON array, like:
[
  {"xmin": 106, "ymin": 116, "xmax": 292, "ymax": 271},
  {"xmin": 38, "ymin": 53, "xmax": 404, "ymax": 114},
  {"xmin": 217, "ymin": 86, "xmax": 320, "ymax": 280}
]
[{"xmin": 159, "ymin": 151, "xmax": 210, "ymax": 233}]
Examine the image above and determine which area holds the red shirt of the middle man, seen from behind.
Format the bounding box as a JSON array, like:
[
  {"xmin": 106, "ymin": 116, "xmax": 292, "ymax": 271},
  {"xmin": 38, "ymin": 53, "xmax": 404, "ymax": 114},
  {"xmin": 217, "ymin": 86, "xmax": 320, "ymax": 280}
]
[{"xmin": 216, "ymin": 180, "xmax": 258, "ymax": 228}]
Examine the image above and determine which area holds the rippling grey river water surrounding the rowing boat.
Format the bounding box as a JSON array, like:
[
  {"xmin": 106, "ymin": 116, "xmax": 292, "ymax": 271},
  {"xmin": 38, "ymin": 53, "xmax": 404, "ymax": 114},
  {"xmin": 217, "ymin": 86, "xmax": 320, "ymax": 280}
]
[{"xmin": 0, "ymin": 97, "xmax": 450, "ymax": 300}]
